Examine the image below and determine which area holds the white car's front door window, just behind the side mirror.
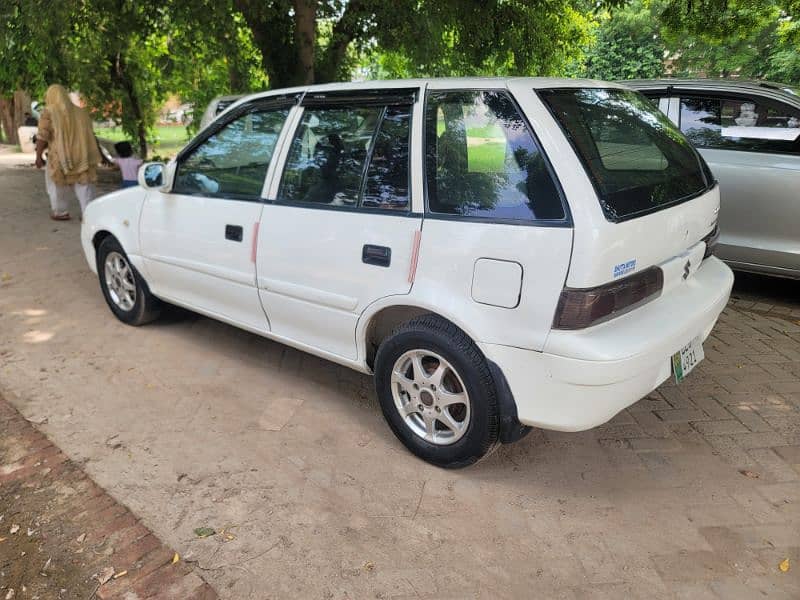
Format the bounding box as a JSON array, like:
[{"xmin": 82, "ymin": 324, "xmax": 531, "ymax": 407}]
[{"xmin": 172, "ymin": 108, "xmax": 289, "ymax": 199}]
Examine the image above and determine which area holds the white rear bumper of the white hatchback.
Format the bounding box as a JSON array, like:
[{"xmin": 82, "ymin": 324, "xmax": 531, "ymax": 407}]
[{"xmin": 480, "ymin": 257, "xmax": 733, "ymax": 431}]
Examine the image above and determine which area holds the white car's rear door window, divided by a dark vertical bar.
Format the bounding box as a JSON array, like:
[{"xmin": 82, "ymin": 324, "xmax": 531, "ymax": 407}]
[{"xmin": 278, "ymin": 106, "xmax": 411, "ymax": 210}]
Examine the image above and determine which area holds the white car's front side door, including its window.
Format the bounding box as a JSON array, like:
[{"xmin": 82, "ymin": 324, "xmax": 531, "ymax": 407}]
[{"xmin": 140, "ymin": 98, "xmax": 294, "ymax": 332}]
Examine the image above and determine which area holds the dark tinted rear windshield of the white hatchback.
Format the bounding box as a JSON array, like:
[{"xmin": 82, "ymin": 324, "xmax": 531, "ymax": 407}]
[{"xmin": 539, "ymin": 88, "xmax": 713, "ymax": 222}]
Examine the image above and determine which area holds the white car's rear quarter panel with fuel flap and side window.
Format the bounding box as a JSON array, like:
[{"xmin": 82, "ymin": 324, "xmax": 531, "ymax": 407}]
[{"xmin": 406, "ymin": 80, "xmax": 573, "ymax": 350}]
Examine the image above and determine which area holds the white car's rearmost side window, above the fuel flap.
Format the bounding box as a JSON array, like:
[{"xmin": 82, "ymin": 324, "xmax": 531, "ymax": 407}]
[{"xmin": 425, "ymin": 90, "xmax": 565, "ymax": 221}]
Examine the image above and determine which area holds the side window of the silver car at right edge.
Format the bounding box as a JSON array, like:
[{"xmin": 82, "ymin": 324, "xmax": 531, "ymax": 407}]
[{"xmin": 680, "ymin": 96, "xmax": 800, "ymax": 153}]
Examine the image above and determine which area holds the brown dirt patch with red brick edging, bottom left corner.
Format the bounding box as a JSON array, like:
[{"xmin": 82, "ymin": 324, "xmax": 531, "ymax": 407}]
[{"xmin": 0, "ymin": 397, "xmax": 217, "ymax": 600}]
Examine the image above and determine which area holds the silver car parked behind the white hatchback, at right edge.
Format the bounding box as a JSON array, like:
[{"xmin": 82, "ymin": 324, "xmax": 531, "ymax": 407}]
[{"xmin": 624, "ymin": 79, "xmax": 800, "ymax": 278}]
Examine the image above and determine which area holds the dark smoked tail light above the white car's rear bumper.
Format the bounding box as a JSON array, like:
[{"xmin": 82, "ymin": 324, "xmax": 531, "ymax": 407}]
[{"xmin": 553, "ymin": 267, "xmax": 664, "ymax": 329}]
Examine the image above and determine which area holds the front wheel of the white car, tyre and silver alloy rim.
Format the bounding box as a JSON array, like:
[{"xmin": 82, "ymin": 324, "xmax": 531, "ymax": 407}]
[{"xmin": 97, "ymin": 236, "xmax": 161, "ymax": 326}]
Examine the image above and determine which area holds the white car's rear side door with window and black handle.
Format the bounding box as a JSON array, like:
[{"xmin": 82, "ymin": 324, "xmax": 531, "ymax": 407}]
[{"xmin": 257, "ymin": 88, "xmax": 422, "ymax": 360}]
